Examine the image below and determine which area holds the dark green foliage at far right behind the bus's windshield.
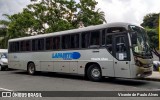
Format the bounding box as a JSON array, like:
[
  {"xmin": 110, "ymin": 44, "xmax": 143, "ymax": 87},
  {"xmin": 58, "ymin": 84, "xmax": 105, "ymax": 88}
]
[{"xmin": 141, "ymin": 13, "xmax": 159, "ymax": 48}]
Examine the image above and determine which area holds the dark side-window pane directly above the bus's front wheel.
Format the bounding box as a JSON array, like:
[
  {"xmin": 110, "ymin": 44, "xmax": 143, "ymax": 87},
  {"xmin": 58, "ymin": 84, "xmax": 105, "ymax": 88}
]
[{"xmin": 89, "ymin": 31, "xmax": 100, "ymax": 48}]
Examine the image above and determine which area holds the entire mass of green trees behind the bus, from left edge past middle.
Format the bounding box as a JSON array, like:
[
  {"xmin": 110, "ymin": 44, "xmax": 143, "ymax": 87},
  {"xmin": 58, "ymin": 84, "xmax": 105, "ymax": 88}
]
[{"xmin": 0, "ymin": 0, "xmax": 106, "ymax": 47}]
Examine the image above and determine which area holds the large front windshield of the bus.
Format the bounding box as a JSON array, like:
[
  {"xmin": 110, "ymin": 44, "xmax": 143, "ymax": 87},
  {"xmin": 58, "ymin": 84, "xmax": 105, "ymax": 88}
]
[{"xmin": 130, "ymin": 25, "xmax": 152, "ymax": 56}]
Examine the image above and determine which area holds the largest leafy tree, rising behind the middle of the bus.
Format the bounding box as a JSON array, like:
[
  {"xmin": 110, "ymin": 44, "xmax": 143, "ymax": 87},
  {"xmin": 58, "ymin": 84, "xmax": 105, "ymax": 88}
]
[{"xmin": 28, "ymin": 0, "xmax": 106, "ymax": 33}]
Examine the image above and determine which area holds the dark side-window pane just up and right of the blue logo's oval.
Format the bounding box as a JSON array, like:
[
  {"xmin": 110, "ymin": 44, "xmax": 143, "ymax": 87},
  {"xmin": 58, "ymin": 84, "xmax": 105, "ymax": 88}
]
[{"xmin": 81, "ymin": 32, "xmax": 89, "ymax": 48}]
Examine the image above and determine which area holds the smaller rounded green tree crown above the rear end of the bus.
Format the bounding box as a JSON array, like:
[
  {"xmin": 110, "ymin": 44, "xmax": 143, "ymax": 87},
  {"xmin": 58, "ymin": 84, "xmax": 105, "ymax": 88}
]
[{"xmin": 8, "ymin": 9, "xmax": 36, "ymax": 38}]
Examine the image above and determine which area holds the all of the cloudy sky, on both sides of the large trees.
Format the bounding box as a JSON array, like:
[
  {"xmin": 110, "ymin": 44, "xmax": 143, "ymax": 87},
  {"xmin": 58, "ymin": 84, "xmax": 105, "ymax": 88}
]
[{"xmin": 0, "ymin": 0, "xmax": 160, "ymax": 25}]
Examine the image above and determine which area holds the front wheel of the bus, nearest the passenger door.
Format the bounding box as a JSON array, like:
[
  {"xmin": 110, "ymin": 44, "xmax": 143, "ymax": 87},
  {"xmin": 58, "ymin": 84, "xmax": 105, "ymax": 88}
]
[{"xmin": 87, "ymin": 64, "xmax": 102, "ymax": 82}]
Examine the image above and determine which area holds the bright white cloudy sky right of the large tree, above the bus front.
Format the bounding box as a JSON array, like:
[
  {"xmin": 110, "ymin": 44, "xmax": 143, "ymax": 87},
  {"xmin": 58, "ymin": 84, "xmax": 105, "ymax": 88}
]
[{"xmin": 96, "ymin": 0, "xmax": 160, "ymax": 25}]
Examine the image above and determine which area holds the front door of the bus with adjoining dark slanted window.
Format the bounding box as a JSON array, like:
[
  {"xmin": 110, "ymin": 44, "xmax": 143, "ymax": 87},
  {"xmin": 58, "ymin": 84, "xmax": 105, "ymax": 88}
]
[{"xmin": 106, "ymin": 33, "xmax": 130, "ymax": 78}]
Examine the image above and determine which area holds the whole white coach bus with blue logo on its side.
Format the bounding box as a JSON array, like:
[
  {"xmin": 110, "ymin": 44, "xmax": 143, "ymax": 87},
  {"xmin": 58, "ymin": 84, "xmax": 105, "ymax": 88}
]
[{"xmin": 8, "ymin": 23, "xmax": 153, "ymax": 81}]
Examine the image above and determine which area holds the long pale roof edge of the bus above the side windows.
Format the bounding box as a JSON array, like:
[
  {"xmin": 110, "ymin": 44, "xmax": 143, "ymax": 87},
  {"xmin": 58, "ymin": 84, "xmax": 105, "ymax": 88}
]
[{"xmin": 9, "ymin": 22, "xmax": 131, "ymax": 42}]
